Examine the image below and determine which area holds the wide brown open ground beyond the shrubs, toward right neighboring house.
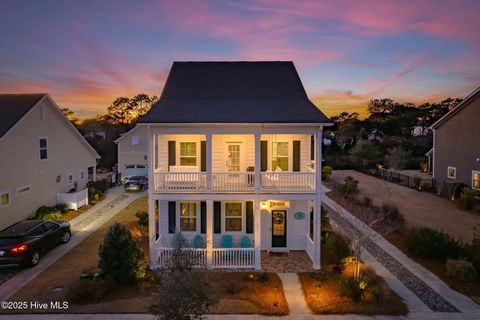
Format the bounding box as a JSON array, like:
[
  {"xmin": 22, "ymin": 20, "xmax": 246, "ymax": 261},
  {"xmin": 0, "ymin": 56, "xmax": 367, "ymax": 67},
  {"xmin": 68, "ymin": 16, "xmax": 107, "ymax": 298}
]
[{"xmin": 330, "ymin": 170, "xmax": 480, "ymax": 242}]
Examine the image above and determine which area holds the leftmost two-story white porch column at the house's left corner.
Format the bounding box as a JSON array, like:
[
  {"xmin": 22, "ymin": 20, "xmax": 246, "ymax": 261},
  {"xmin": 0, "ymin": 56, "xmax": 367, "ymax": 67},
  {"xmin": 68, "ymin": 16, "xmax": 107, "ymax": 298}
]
[{"xmin": 147, "ymin": 126, "xmax": 156, "ymax": 269}]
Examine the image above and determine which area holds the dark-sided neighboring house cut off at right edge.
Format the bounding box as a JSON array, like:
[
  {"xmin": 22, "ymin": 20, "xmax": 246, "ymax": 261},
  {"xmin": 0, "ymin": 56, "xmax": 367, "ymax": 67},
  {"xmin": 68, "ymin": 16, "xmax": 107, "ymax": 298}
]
[{"xmin": 427, "ymin": 88, "xmax": 480, "ymax": 194}]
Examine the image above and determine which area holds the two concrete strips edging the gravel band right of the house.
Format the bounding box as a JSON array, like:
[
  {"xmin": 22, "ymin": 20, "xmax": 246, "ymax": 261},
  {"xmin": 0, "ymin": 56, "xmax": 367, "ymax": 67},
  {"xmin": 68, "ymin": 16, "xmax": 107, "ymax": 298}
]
[{"xmin": 323, "ymin": 196, "xmax": 480, "ymax": 319}]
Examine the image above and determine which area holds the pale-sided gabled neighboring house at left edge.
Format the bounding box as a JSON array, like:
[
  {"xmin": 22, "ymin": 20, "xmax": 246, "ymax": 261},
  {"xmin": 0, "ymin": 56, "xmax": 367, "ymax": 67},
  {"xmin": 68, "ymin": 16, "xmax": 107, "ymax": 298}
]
[{"xmin": 0, "ymin": 94, "xmax": 100, "ymax": 229}]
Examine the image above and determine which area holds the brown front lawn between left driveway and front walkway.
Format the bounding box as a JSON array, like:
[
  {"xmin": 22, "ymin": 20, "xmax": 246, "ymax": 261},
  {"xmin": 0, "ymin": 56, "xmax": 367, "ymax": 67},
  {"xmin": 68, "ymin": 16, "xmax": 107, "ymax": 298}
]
[{"xmin": 0, "ymin": 197, "xmax": 288, "ymax": 315}]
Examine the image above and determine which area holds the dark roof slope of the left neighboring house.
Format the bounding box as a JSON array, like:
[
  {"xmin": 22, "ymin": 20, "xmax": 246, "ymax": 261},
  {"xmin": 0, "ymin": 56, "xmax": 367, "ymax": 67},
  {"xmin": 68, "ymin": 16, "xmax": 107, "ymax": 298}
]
[{"xmin": 0, "ymin": 93, "xmax": 45, "ymax": 138}]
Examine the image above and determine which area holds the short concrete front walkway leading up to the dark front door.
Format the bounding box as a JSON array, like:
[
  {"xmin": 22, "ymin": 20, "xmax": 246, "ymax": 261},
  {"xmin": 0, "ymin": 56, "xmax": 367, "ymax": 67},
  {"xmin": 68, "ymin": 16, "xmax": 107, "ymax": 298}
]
[{"xmin": 278, "ymin": 273, "xmax": 312, "ymax": 315}]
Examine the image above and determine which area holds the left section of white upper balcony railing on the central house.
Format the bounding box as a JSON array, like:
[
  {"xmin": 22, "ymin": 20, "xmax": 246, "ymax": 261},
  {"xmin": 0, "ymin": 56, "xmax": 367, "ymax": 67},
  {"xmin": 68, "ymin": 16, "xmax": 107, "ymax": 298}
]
[{"xmin": 154, "ymin": 172, "xmax": 207, "ymax": 191}]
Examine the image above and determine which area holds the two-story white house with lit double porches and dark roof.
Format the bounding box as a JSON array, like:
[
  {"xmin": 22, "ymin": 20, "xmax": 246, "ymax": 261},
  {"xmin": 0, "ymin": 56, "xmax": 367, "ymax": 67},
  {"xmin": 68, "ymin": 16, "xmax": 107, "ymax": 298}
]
[{"xmin": 138, "ymin": 62, "xmax": 330, "ymax": 269}]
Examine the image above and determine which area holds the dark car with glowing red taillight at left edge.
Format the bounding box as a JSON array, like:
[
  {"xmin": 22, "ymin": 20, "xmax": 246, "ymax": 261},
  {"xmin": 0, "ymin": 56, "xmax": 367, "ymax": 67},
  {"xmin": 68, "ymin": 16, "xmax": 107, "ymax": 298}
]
[{"xmin": 0, "ymin": 220, "xmax": 72, "ymax": 266}]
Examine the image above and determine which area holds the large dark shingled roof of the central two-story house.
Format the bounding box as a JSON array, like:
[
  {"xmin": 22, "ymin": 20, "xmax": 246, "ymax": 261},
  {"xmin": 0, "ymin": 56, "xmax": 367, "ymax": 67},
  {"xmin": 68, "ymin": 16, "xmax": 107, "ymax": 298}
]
[{"xmin": 139, "ymin": 61, "xmax": 330, "ymax": 123}]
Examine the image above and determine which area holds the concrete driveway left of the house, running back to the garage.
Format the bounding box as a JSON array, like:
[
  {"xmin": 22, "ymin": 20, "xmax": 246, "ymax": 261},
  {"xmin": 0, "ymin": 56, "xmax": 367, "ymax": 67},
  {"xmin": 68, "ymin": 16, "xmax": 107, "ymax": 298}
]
[{"xmin": 0, "ymin": 187, "xmax": 145, "ymax": 302}]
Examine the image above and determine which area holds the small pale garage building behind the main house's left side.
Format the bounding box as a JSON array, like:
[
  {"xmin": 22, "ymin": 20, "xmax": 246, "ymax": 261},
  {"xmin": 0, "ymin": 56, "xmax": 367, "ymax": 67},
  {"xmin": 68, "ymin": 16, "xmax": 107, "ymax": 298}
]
[{"xmin": 115, "ymin": 126, "xmax": 148, "ymax": 180}]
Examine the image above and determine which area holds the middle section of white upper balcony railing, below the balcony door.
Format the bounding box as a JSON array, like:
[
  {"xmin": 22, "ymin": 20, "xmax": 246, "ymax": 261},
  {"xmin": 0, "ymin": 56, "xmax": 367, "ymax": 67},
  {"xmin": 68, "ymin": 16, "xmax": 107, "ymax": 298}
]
[{"xmin": 212, "ymin": 172, "xmax": 255, "ymax": 191}]
